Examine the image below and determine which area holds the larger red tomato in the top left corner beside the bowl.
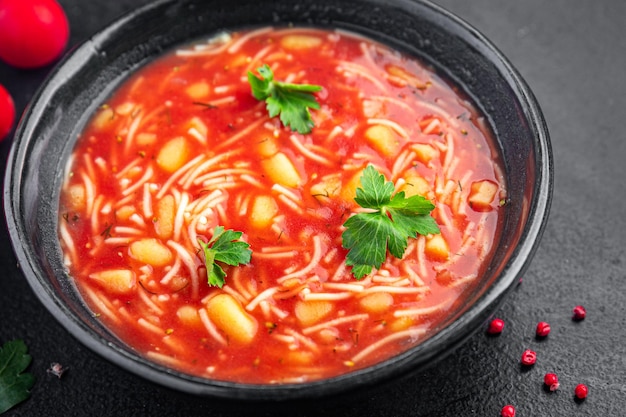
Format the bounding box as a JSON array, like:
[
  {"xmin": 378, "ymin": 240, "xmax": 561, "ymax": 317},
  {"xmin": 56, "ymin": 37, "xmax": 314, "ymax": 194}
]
[{"xmin": 0, "ymin": 0, "xmax": 70, "ymax": 68}]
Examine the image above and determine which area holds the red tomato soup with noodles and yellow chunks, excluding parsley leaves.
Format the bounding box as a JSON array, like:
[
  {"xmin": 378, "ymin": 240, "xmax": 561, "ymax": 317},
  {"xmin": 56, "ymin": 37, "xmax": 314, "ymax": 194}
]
[{"xmin": 59, "ymin": 27, "xmax": 506, "ymax": 384}]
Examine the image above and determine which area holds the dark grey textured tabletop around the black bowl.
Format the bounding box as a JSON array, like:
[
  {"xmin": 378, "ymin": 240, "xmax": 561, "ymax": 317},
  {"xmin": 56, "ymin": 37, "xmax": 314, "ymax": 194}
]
[{"xmin": 0, "ymin": 0, "xmax": 626, "ymax": 417}]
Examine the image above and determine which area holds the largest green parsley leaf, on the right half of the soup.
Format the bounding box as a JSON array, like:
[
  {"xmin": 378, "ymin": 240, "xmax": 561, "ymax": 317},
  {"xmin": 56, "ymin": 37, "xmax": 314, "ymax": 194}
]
[{"xmin": 342, "ymin": 165, "xmax": 440, "ymax": 279}]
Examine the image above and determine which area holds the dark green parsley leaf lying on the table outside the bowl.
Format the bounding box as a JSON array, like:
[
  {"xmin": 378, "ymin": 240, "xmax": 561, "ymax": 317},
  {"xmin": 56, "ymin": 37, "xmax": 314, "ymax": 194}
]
[{"xmin": 0, "ymin": 340, "xmax": 35, "ymax": 414}]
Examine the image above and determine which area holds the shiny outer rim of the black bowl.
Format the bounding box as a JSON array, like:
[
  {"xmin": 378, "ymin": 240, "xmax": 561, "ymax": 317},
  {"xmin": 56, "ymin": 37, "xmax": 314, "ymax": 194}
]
[{"xmin": 3, "ymin": 0, "xmax": 554, "ymax": 400}]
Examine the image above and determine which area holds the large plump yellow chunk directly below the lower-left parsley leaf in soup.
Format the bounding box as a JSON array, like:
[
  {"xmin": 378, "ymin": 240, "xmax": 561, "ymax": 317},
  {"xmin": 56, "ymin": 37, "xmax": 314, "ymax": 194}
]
[{"xmin": 206, "ymin": 294, "xmax": 258, "ymax": 344}]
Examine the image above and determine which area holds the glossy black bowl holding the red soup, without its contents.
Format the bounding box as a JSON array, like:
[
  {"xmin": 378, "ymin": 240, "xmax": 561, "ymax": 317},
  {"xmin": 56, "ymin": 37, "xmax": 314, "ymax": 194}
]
[{"xmin": 4, "ymin": 0, "xmax": 553, "ymax": 400}]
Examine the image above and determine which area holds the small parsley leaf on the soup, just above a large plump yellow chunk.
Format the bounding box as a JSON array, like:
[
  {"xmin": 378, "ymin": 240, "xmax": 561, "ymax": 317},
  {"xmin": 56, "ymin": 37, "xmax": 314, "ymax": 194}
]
[{"xmin": 198, "ymin": 226, "xmax": 252, "ymax": 288}]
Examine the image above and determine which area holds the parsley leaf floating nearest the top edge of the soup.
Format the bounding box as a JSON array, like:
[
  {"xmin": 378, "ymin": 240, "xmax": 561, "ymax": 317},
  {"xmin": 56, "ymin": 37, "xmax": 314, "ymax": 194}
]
[{"xmin": 248, "ymin": 64, "xmax": 322, "ymax": 134}]
